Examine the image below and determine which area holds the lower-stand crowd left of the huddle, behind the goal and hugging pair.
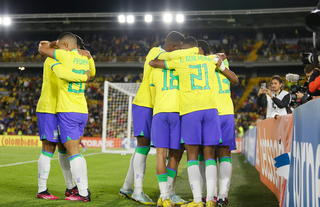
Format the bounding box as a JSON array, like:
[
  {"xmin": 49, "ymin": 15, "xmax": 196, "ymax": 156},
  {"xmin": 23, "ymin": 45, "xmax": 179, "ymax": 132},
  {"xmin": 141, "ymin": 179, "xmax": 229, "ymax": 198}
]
[{"xmin": 0, "ymin": 74, "xmax": 142, "ymax": 137}]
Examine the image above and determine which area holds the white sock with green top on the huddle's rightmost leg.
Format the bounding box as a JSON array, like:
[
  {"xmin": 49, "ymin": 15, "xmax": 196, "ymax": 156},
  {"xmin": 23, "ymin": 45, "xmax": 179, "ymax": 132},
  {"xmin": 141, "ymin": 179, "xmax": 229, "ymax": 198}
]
[{"xmin": 218, "ymin": 157, "xmax": 232, "ymax": 200}]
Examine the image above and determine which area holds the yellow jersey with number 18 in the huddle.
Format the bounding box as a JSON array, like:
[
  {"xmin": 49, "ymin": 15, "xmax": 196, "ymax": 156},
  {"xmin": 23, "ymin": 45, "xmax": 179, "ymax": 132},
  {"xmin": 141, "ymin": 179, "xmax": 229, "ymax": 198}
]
[{"xmin": 150, "ymin": 69, "xmax": 179, "ymax": 115}]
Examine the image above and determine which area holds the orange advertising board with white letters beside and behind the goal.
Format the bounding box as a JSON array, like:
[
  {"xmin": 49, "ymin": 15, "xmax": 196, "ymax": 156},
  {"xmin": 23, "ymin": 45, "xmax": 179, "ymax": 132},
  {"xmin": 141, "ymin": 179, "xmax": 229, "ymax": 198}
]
[{"xmin": 81, "ymin": 137, "xmax": 122, "ymax": 149}]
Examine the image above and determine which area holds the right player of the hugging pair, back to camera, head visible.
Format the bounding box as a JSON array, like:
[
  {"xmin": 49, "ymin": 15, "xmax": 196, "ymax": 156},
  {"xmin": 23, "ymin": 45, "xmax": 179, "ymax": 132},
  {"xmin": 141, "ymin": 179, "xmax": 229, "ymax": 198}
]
[{"xmin": 39, "ymin": 32, "xmax": 91, "ymax": 202}]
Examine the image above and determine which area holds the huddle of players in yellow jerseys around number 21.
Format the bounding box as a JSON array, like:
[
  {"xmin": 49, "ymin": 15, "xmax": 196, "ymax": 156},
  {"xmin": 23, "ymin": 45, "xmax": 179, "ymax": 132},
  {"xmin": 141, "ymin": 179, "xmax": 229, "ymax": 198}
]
[{"xmin": 119, "ymin": 31, "xmax": 238, "ymax": 207}]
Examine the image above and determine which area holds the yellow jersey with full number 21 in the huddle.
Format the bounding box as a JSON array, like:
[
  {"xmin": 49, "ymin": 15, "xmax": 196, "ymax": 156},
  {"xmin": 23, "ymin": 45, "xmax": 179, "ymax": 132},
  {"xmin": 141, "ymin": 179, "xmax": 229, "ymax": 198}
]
[{"xmin": 165, "ymin": 55, "xmax": 217, "ymax": 115}]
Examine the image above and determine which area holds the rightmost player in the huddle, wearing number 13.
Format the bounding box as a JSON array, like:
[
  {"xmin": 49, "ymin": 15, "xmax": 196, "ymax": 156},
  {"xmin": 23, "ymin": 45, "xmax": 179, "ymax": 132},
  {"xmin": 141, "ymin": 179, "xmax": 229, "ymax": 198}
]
[{"xmin": 198, "ymin": 40, "xmax": 239, "ymax": 206}]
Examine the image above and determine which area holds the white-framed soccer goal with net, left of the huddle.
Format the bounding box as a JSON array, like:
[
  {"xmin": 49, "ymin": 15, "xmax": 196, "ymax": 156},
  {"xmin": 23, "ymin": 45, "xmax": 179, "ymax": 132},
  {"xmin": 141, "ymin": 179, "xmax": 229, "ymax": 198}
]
[{"xmin": 101, "ymin": 81, "xmax": 140, "ymax": 153}]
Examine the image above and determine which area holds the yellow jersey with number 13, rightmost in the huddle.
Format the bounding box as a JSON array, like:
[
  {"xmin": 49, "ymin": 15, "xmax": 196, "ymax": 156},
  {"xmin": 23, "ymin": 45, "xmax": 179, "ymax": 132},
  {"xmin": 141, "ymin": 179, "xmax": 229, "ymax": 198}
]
[{"xmin": 207, "ymin": 55, "xmax": 234, "ymax": 115}]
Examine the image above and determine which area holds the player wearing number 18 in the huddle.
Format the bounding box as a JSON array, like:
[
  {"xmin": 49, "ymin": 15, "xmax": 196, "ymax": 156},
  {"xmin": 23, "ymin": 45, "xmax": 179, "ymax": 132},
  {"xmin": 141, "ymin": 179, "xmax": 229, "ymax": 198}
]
[{"xmin": 150, "ymin": 53, "xmax": 185, "ymax": 207}]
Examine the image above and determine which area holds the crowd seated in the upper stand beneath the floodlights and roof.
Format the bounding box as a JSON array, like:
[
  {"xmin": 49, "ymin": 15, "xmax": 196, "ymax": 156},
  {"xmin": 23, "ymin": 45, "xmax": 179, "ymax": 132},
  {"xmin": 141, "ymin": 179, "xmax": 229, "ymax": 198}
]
[{"xmin": 0, "ymin": 33, "xmax": 312, "ymax": 62}]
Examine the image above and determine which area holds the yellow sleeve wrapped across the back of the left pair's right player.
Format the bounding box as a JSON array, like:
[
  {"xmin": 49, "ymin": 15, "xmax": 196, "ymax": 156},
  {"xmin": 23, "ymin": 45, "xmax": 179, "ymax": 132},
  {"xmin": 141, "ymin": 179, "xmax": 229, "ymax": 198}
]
[{"xmin": 51, "ymin": 62, "xmax": 88, "ymax": 82}]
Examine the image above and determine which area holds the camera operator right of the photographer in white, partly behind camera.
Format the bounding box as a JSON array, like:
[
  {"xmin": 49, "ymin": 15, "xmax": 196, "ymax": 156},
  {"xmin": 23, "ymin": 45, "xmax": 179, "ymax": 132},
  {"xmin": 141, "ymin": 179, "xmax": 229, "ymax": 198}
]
[{"xmin": 296, "ymin": 64, "xmax": 320, "ymax": 105}]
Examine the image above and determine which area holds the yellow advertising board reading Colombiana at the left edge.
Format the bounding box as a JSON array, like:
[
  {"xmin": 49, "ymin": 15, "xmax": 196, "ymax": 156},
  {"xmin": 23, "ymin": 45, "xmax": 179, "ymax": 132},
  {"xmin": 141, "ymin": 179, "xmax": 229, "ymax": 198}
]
[{"xmin": 0, "ymin": 135, "xmax": 42, "ymax": 147}]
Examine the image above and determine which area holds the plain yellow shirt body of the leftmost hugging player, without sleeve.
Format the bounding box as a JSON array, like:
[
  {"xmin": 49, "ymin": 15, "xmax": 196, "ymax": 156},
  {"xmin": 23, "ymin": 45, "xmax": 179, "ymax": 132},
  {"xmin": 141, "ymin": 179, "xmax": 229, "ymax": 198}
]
[{"xmin": 36, "ymin": 57, "xmax": 58, "ymax": 114}]
